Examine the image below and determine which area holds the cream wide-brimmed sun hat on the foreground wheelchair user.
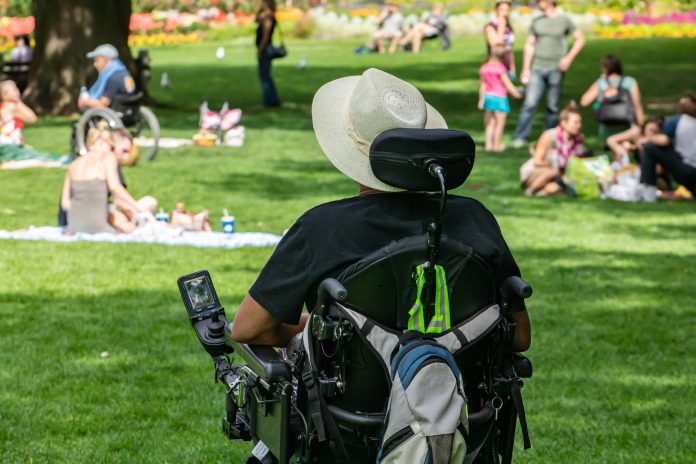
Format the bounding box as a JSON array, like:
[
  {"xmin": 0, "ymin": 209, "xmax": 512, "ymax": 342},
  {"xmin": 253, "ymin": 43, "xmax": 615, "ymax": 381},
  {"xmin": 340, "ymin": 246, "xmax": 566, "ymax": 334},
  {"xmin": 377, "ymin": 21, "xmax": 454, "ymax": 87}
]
[{"xmin": 312, "ymin": 68, "xmax": 447, "ymax": 192}]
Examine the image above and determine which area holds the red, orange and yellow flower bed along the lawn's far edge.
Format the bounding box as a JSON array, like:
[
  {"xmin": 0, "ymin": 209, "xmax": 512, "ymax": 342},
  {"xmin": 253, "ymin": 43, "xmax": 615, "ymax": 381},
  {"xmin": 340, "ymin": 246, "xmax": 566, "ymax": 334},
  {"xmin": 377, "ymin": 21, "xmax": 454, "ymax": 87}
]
[{"xmin": 0, "ymin": 6, "xmax": 696, "ymax": 52}]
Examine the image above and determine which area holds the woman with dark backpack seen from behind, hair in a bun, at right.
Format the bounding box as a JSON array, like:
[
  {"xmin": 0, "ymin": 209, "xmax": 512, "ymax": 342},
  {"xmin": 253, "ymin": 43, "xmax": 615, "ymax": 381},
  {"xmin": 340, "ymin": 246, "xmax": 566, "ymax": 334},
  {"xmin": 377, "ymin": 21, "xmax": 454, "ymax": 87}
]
[{"xmin": 580, "ymin": 54, "xmax": 644, "ymax": 149}]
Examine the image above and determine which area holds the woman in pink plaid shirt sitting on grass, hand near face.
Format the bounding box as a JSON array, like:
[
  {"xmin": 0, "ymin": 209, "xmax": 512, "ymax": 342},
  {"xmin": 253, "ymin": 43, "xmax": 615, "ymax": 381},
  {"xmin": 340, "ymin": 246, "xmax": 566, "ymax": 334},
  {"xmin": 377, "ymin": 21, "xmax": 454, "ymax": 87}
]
[{"xmin": 520, "ymin": 103, "xmax": 587, "ymax": 196}]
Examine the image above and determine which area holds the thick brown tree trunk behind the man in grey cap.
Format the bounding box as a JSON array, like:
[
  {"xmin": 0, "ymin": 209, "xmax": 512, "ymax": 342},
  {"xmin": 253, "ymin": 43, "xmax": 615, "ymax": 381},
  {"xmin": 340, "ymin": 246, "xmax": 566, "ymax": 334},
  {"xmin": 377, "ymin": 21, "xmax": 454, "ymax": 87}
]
[{"xmin": 25, "ymin": 0, "xmax": 135, "ymax": 115}]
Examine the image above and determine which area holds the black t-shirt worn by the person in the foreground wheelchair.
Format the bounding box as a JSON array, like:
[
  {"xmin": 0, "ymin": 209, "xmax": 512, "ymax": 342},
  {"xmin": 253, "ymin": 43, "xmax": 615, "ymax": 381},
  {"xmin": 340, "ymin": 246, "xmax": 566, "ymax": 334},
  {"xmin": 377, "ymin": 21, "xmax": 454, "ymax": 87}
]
[{"xmin": 249, "ymin": 193, "xmax": 524, "ymax": 324}]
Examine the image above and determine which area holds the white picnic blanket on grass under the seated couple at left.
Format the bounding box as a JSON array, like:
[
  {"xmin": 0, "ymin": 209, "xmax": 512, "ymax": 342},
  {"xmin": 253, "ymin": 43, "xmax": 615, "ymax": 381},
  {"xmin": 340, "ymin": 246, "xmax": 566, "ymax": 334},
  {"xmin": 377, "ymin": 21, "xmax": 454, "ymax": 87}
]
[{"xmin": 0, "ymin": 223, "xmax": 281, "ymax": 248}]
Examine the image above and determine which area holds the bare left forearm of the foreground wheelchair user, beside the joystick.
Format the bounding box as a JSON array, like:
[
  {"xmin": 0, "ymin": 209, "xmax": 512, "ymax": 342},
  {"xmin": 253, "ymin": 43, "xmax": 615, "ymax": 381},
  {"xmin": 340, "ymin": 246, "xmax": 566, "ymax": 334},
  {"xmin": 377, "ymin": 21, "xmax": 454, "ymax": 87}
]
[{"xmin": 232, "ymin": 294, "xmax": 309, "ymax": 346}]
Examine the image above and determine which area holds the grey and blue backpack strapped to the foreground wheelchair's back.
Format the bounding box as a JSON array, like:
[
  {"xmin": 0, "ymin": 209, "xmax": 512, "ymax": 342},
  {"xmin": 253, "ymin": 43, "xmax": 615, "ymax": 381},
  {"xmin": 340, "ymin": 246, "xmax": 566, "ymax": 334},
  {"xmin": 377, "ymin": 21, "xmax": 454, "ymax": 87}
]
[{"xmin": 303, "ymin": 303, "xmax": 501, "ymax": 464}]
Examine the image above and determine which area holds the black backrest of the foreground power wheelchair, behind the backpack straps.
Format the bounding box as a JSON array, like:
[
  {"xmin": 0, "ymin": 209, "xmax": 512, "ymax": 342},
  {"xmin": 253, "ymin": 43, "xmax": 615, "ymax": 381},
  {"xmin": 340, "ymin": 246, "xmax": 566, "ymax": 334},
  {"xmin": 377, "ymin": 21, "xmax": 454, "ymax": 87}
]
[{"xmin": 315, "ymin": 236, "xmax": 497, "ymax": 413}]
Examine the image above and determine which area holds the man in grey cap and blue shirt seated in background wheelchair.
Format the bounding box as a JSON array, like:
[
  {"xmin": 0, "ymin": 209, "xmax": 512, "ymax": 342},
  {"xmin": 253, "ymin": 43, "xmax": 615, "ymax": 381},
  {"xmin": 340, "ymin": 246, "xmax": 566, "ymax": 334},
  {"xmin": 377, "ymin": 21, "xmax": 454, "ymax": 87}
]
[{"xmin": 77, "ymin": 44, "xmax": 135, "ymax": 109}]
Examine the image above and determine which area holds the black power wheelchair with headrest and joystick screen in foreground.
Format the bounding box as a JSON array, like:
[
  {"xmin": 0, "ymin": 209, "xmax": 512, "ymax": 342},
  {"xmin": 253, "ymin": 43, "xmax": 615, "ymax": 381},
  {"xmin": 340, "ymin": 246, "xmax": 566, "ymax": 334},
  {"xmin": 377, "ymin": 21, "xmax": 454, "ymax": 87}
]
[{"xmin": 178, "ymin": 129, "xmax": 532, "ymax": 463}]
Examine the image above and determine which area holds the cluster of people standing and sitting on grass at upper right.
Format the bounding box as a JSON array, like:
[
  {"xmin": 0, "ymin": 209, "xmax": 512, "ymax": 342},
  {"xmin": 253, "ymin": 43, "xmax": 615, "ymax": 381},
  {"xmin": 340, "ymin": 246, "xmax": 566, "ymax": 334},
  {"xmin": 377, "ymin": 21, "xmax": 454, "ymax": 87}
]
[{"xmin": 478, "ymin": 0, "xmax": 696, "ymax": 201}]
